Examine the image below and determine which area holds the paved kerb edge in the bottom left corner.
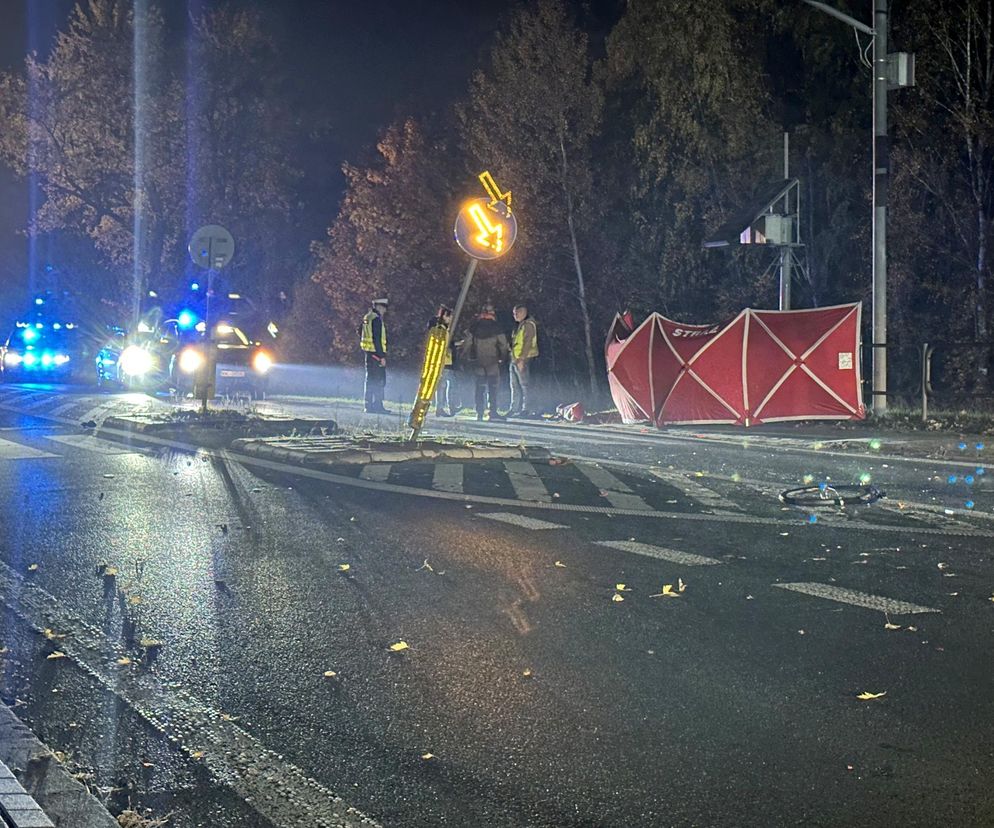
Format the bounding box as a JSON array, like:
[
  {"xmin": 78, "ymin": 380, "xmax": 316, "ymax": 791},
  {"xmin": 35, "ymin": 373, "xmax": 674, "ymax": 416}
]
[{"xmin": 0, "ymin": 704, "xmax": 119, "ymax": 828}]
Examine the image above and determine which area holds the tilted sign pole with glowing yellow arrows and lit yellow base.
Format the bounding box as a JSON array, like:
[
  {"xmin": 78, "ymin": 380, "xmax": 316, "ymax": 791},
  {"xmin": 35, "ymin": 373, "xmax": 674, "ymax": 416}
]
[{"xmin": 407, "ymin": 171, "xmax": 518, "ymax": 442}]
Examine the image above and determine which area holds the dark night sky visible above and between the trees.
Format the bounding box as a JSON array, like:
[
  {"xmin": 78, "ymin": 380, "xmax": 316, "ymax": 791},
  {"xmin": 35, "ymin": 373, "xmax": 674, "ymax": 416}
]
[{"xmin": 0, "ymin": 0, "xmax": 621, "ymax": 321}]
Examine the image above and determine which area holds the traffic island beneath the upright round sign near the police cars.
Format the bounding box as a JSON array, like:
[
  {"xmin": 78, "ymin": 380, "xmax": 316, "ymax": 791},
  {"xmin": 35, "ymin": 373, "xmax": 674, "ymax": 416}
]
[{"xmin": 100, "ymin": 409, "xmax": 338, "ymax": 449}]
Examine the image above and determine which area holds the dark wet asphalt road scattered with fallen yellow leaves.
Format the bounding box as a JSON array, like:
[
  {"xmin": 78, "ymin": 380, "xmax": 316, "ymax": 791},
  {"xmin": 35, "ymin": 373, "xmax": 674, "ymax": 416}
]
[{"xmin": 0, "ymin": 384, "xmax": 994, "ymax": 828}]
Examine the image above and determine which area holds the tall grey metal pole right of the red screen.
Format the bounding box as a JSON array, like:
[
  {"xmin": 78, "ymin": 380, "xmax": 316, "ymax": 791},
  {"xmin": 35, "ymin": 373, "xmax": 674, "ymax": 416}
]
[{"xmin": 872, "ymin": 0, "xmax": 890, "ymax": 415}]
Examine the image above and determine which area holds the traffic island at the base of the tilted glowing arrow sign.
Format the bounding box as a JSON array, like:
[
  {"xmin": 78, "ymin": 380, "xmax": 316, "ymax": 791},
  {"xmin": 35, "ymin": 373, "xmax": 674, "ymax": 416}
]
[{"xmin": 231, "ymin": 434, "xmax": 550, "ymax": 466}]
